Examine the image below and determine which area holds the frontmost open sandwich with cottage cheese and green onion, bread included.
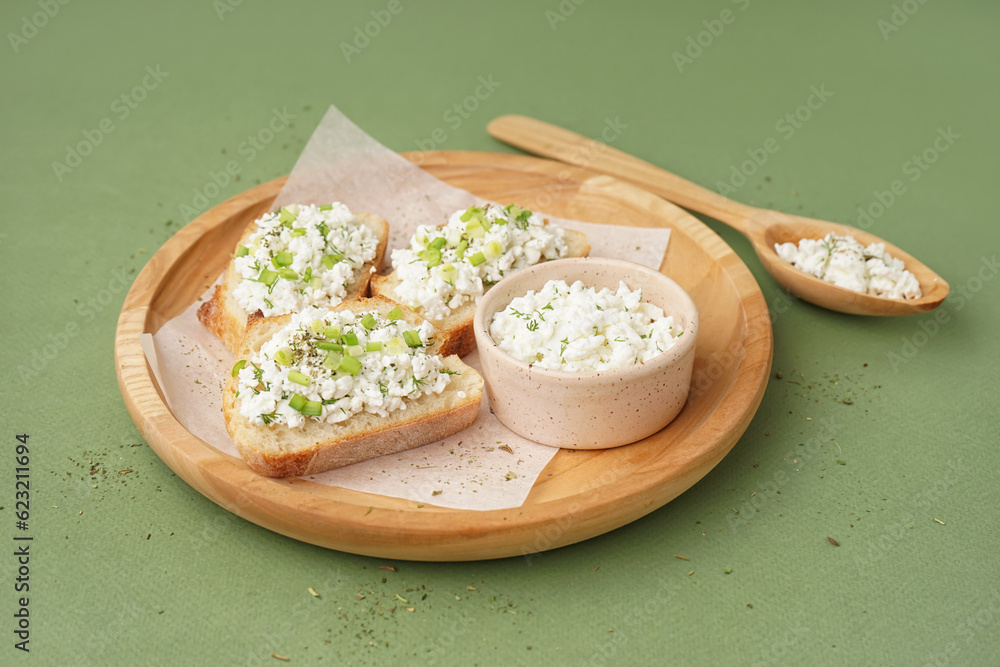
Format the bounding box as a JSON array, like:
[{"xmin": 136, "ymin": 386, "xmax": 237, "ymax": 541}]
[{"xmin": 223, "ymin": 297, "xmax": 483, "ymax": 477}]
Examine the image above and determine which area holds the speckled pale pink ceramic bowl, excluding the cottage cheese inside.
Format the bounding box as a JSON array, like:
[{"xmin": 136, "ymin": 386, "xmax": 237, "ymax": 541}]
[{"xmin": 474, "ymin": 257, "xmax": 698, "ymax": 449}]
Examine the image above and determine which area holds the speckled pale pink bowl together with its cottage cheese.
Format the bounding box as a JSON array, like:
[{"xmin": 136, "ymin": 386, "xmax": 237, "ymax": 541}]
[{"xmin": 473, "ymin": 257, "xmax": 698, "ymax": 449}]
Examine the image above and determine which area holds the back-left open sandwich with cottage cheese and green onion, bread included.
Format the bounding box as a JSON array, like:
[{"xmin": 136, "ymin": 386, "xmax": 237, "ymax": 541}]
[{"xmin": 198, "ymin": 203, "xmax": 389, "ymax": 353}]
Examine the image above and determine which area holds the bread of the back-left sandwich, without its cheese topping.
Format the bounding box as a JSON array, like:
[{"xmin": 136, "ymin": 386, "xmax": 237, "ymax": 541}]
[{"xmin": 198, "ymin": 213, "xmax": 389, "ymax": 354}]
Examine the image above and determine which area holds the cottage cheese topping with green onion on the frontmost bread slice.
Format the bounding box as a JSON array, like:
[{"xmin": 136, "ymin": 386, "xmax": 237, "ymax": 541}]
[{"xmin": 234, "ymin": 306, "xmax": 453, "ymax": 428}]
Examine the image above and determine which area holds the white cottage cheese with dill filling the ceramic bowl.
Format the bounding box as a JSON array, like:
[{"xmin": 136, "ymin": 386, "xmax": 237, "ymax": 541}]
[{"xmin": 490, "ymin": 280, "xmax": 684, "ymax": 372}]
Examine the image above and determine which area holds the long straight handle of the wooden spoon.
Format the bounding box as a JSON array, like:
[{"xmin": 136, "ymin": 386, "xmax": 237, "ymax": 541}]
[{"xmin": 486, "ymin": 115, "xmax": 763, "ymax": 236}]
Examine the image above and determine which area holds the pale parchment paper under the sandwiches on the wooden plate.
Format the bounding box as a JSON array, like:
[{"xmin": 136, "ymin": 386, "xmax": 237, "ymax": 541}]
[{"xmin": 143, "ymin": 107, "xmax": 670, "ymax": 510}]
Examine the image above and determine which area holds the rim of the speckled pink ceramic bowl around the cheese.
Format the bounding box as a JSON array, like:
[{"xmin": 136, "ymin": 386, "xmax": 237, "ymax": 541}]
[{"xmin": 473, "ymin": 257, "xmax": 700, "ymax": 382}]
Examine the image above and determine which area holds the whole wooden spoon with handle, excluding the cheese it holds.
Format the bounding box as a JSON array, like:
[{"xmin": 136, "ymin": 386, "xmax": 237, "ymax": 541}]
[{"xmin": 486, "ymin": 116, "xmax": 948, "ymax": 315}]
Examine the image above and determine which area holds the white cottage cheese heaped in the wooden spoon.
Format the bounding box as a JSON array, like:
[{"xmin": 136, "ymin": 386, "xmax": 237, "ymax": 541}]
[{"xmin": 774, "ymin": 232, "xmax": 921, "ymax": 299}]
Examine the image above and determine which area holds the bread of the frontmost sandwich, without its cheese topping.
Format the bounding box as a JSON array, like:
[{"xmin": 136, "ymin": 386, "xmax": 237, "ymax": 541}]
[{"xmin": 222, "ymin": 297, "xmax": 483, "ymax": 477}]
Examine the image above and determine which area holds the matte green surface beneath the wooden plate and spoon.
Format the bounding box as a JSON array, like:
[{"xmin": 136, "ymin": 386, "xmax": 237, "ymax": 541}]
[{"xmin": 0, "ymin": 0, "xmax": 1000, "ymax": 665}]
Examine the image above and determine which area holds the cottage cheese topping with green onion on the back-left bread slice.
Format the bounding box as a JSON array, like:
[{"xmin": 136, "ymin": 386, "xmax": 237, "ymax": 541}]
[{"xmin": 233, "ymin": 202, "xmax": 378, "ymax": 317}]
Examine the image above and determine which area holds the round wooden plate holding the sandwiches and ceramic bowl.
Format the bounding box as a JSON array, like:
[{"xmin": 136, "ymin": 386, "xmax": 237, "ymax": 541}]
[{"xmin": 115, "ymin": 152, "xmax": 773, "ymax": 561}]
